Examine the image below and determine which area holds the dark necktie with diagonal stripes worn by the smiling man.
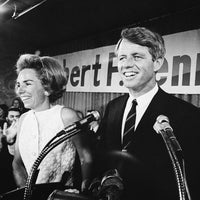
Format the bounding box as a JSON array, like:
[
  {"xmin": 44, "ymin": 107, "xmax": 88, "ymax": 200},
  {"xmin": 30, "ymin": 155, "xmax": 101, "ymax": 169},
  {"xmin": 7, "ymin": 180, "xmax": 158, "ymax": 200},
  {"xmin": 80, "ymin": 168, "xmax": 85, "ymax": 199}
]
[{"xmin": 122, "ymin": 99, "xmax": 137, "ymax": 149}]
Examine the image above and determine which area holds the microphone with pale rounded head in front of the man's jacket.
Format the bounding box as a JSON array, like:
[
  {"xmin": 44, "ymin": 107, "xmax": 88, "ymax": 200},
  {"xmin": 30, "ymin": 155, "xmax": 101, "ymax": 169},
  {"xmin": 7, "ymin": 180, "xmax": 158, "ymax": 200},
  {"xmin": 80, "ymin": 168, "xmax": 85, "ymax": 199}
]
[{"xmin": 153, "ymin": 115, "xmax": 182, "ymax": 151}]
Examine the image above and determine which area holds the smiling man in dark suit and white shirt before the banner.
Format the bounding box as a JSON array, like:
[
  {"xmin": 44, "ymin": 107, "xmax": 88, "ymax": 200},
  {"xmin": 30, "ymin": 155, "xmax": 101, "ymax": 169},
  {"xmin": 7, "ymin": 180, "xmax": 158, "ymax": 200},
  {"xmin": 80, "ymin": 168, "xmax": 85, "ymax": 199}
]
[{"xmin": 96, "ymin": 27, "xmax": 200, "ymax": 200}]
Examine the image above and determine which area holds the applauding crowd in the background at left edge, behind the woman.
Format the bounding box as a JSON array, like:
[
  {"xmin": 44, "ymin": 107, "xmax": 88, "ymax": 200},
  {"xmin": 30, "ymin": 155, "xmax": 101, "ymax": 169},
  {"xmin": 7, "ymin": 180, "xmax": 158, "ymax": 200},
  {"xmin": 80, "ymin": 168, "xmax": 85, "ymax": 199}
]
[{"xmin": 0, "ymin": 97, "xmax": 28, "ymax": 193}]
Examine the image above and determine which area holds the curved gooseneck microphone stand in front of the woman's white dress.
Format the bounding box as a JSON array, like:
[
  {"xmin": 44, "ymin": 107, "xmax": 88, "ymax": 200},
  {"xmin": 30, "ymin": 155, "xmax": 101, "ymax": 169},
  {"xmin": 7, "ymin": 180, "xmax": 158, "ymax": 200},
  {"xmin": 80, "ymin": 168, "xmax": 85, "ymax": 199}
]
[{"xmin": 23, "ymin": 129, "xmax": 81, "ymax": 200}]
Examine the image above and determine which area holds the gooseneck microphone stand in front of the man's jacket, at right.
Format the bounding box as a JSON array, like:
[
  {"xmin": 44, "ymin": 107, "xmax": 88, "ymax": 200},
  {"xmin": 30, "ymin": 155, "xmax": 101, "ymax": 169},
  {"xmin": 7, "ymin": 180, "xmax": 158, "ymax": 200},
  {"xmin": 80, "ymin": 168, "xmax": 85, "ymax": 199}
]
[{"xmin": 159, "ymin": 129, "xmax": 191, "ymax": 200}]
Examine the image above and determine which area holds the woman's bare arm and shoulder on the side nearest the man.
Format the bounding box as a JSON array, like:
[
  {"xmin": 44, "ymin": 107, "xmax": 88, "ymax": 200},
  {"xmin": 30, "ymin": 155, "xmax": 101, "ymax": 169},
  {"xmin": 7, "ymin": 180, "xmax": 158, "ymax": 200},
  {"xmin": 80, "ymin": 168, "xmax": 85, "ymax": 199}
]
[{"xmin": 62, "ymin": 108, "xmax": 93, "ymax": 191}]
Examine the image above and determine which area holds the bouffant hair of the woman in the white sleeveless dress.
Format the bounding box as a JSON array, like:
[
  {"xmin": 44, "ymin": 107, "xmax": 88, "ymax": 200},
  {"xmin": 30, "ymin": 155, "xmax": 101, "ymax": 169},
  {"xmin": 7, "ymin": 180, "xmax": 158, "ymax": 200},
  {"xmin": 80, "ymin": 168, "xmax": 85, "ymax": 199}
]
[{"xmin": 16, "ymin": 54, "xmax": 67, "ymax": 103}]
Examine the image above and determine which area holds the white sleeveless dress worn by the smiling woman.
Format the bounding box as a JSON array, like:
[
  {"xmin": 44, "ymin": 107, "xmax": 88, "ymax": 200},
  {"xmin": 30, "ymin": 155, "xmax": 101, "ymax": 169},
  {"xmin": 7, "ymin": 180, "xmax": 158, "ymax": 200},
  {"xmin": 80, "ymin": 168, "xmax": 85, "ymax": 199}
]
[{"xmin": 19, "ymin": 105, "xmax": 76, "ymax": 186}]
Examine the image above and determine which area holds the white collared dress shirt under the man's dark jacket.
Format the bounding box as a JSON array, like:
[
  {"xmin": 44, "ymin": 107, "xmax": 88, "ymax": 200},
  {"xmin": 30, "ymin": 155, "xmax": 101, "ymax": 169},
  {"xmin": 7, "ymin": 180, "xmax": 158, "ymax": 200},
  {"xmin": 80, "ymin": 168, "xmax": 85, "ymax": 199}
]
[{"xmin": 121, "ymin": 84, "xmax": 158, "ymax": 142}]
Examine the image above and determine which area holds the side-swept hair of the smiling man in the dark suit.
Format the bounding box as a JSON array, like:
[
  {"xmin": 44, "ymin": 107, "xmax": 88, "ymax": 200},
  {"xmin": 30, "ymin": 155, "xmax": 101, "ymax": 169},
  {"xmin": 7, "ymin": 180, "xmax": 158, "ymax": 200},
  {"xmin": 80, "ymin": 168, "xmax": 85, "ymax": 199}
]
[{"xmin": 115, "ymin": 27, "xmax": 166, "ymax": 61}]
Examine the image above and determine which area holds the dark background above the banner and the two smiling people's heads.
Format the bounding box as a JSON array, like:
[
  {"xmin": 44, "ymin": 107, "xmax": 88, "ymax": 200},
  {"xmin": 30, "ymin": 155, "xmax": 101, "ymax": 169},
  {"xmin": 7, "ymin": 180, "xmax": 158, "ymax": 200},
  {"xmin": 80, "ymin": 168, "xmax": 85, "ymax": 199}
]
[{"xmin": 0, "ymin": 0, "xmax": 200, "ymax": 103}]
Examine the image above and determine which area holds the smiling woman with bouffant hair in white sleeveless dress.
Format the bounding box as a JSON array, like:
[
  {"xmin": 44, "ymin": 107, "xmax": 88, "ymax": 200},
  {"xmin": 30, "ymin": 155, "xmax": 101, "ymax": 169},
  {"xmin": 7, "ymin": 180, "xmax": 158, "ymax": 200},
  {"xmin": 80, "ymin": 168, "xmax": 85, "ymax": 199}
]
[{"xmin": 10, "ymin": 54, "xmax": 92, "ymax": 191}]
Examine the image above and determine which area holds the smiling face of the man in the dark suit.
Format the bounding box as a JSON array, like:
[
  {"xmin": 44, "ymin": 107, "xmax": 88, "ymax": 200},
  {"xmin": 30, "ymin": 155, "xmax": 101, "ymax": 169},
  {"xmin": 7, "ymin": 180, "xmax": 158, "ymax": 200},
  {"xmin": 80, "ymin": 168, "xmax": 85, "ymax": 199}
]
[{"xmin": 117, "ymin": 39, "xmax": 161, "ymax": 94}]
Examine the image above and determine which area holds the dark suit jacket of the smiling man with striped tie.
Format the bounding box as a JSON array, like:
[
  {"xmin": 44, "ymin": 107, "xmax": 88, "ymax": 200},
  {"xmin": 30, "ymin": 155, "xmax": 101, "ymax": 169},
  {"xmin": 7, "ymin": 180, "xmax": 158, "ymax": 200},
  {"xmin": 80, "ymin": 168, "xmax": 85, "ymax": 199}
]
[{"xmin": 96, "ymin": 88, "xmax": 200, "ymax": 200}]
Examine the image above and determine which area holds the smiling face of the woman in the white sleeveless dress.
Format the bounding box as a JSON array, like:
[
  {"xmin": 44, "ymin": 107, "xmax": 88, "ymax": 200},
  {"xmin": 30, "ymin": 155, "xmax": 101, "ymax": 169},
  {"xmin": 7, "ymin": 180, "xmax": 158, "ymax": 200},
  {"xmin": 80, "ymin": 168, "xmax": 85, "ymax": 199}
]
[{"xmin": 16, "ymin": 69, "xmax": 49, "ymax": 111}]
